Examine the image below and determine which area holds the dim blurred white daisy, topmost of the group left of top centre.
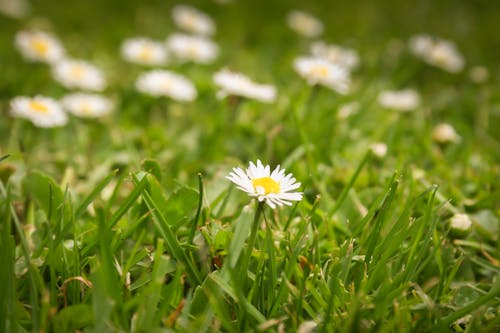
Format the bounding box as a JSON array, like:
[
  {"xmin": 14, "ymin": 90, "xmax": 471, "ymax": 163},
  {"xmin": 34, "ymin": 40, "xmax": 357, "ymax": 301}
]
[{"xmin": 172, "ymin": 5, "xmax": 215, "ymax": 36}]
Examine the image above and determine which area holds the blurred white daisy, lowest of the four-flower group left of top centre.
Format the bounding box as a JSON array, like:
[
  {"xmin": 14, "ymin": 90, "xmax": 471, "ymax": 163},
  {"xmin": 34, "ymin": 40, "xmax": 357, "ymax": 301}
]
[{"xmin": 139, "ymin": 70, "xmax": 197, "ymax": 101}]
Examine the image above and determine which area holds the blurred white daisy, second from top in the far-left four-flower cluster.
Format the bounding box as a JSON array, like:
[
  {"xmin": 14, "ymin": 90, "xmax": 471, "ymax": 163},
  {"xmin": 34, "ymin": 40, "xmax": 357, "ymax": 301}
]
[{"xmin": 52, "ymin": 59, "xmax": 106, "ymax": 91}]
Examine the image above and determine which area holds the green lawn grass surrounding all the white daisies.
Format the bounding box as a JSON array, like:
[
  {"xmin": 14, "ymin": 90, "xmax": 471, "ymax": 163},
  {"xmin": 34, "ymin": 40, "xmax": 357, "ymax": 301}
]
[{"xmin": 0, "ymin": 0, "xmax": 500, "ymax": 332}]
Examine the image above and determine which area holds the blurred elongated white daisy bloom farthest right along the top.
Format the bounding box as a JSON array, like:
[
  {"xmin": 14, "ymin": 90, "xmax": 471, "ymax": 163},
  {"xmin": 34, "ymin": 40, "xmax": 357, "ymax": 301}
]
[{"xmin": 409, "ymin": 34, "xmax": 465, "ymax": 73}]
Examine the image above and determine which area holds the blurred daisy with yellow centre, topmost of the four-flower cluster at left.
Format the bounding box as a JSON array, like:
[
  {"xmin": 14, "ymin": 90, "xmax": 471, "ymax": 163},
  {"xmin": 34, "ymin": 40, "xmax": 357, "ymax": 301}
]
[{"xmin": 15, "ymin": 31, "xmax": 65, "ymax": 63}]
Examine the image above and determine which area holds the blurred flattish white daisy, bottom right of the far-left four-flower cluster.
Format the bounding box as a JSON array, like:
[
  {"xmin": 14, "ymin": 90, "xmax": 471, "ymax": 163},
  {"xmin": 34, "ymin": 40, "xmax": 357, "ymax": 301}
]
[{"xmin": 61, "ymin": 93, "xmax": 113, "ymax": 118}]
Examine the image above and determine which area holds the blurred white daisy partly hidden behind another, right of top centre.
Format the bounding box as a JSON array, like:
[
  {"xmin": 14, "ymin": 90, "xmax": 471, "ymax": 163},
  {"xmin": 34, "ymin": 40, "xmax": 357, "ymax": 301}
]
[{"xmin": 310, "ymin": 41, "xmax": 359, "ymax": 70}]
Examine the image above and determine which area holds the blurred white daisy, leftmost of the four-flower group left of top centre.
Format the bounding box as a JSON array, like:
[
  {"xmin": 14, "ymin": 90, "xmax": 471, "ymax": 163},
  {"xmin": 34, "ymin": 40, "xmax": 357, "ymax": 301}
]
[{"xmin": 121, "ymin": 37, "xmax": 168, "ymax": 65}]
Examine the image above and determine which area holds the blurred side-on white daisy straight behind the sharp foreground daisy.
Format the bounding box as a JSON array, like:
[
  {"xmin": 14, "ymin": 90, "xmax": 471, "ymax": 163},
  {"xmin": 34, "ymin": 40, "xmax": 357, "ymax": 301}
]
[{"xmin": 213, "ymin": 68, "xmax": 276, "ymax": 103}]
